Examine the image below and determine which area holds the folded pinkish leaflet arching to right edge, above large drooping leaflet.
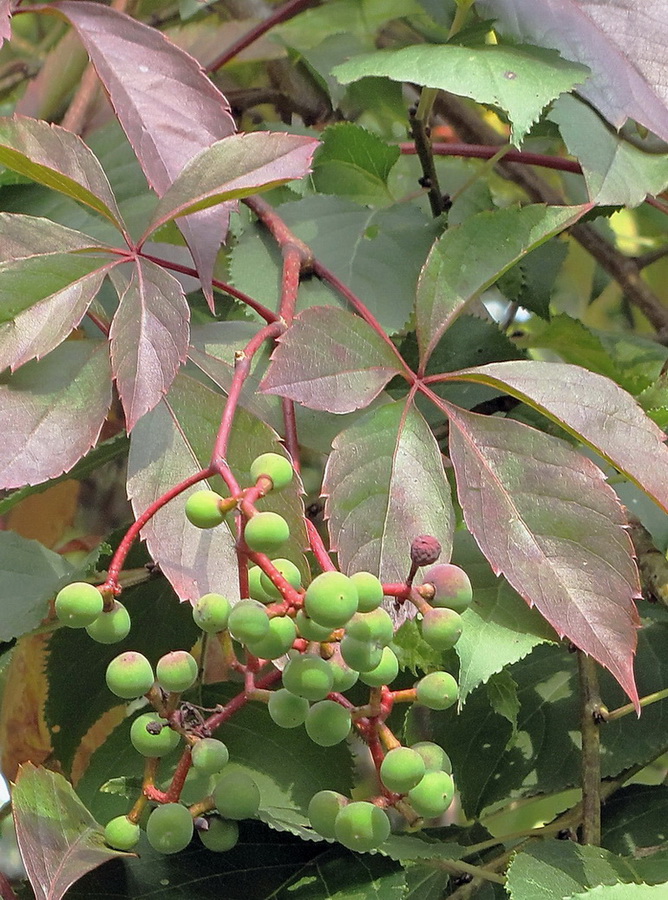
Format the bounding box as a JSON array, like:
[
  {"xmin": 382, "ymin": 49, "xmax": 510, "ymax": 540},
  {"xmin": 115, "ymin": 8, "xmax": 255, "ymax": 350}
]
[{"xmin": 440, "ymin": 360, "xmax": 668, "ymax": 512}]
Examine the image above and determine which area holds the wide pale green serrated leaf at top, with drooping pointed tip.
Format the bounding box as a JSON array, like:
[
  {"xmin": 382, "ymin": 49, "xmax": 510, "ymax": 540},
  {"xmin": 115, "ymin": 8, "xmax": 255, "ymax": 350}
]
[{"xmin": 334, "ymin": 44, "xmax": 589, "ymax": 147}]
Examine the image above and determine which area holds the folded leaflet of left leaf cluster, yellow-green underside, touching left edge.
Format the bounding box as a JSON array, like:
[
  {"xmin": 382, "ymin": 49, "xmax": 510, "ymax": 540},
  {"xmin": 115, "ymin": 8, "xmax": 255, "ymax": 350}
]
[{"xmin": 0, "ymin": 116, "xmax": 125, "ymax": 231}]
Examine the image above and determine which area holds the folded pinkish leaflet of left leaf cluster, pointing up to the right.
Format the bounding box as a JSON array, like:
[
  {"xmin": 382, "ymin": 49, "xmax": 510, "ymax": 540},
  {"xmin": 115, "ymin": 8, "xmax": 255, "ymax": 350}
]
[{"xmin": 146, "ymin": 131, "xmax": 319, "ymax": 235}]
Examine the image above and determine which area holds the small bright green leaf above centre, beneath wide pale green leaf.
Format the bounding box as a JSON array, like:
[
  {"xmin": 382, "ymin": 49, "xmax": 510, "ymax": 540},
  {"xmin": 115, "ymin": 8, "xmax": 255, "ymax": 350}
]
[{"xmin": 312, "ymin": 122, "xmax": 401, "ymax": 206}]
